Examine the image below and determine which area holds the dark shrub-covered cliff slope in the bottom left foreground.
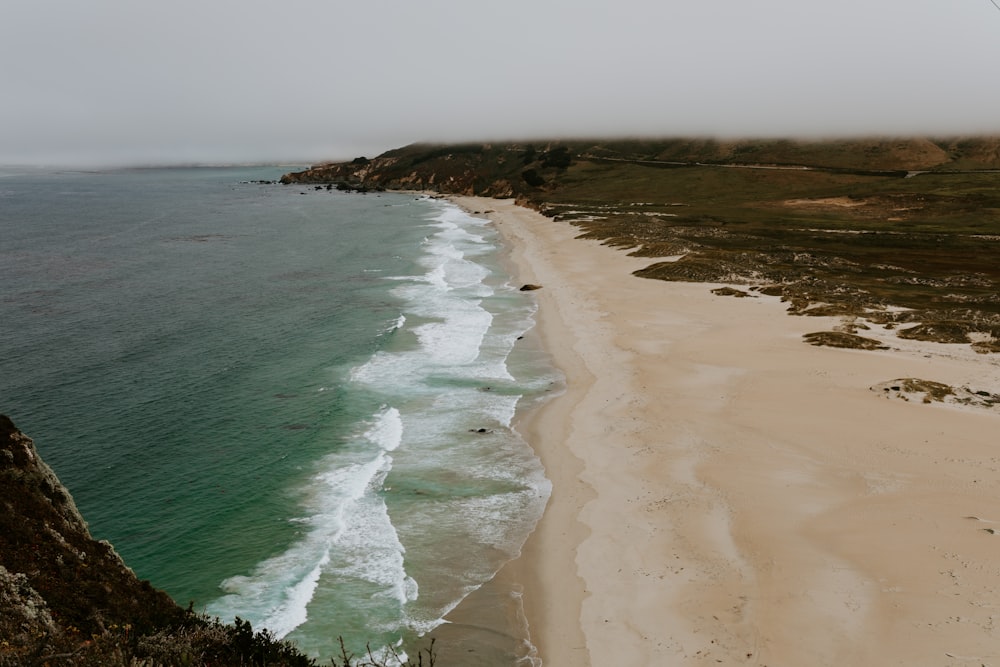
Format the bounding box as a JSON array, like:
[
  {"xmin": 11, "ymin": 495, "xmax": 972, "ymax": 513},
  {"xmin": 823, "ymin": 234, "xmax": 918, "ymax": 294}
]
[{"xmin": 0, "ymin": 415, "xmax": 314, "ymax": 667}]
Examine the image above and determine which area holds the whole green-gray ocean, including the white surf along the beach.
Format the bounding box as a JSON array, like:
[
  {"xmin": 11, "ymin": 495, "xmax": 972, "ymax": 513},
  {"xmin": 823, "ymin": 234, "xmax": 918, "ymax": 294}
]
[{"xmin": 0, "ymin": 167, "xmax": 560, "ymax": 664}]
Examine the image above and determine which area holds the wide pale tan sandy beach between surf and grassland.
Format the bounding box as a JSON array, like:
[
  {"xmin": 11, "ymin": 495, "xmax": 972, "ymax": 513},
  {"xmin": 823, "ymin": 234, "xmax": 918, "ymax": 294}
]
[{"xmin": 442, "ymin": 197, "xmax": 1000, "ymax": 667}]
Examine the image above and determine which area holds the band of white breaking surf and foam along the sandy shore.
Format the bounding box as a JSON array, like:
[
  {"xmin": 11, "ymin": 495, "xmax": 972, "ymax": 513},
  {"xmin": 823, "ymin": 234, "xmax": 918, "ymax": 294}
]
[{"xmin": 210, "ymin": 197, "xmax": 550, "ymax": 650}]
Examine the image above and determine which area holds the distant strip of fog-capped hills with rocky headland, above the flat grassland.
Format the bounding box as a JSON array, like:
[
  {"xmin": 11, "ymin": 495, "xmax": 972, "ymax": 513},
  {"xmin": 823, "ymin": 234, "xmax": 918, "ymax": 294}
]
[{"xmin": 282, "ymin": 137, "xmax": 1000, "ymax": 194}]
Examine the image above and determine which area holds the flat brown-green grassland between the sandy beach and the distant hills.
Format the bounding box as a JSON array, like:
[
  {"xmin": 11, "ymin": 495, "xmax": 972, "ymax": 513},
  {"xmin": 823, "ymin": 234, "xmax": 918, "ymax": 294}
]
[{"xmin": 541, "ymin": 153, "xmax": 1000, "ymax": 335}]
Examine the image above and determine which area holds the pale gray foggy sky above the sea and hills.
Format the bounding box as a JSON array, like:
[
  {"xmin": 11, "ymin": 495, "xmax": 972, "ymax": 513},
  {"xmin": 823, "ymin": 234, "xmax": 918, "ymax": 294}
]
[{"xmin": 0, "ymin": 0, "xmax": 1000, "ymax": 165}]
